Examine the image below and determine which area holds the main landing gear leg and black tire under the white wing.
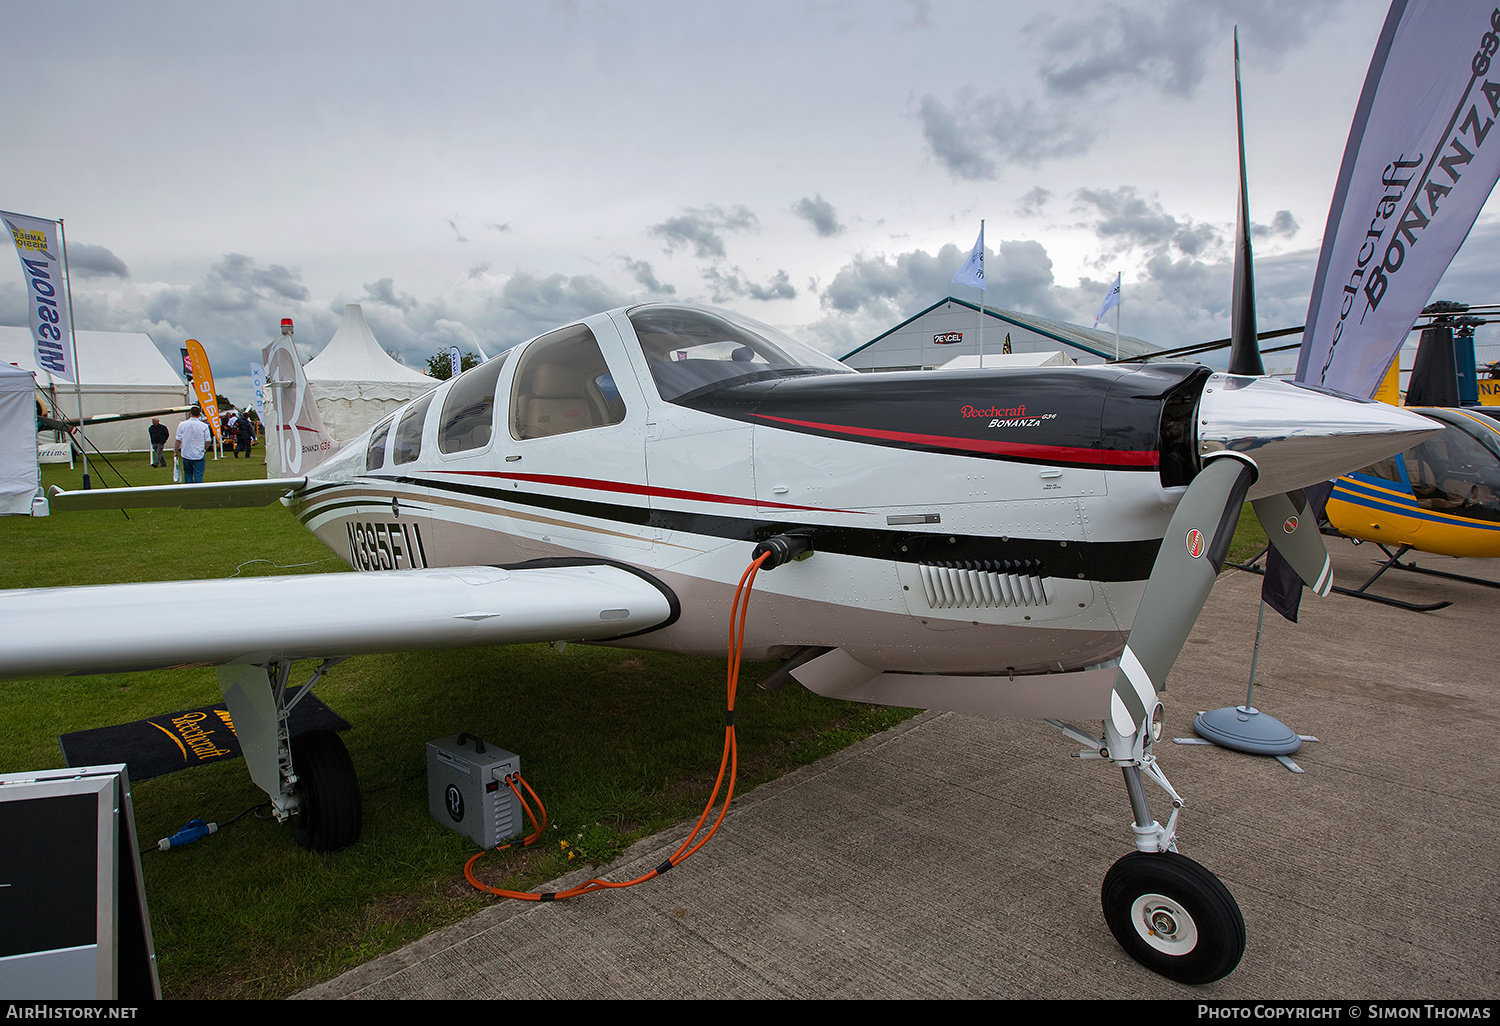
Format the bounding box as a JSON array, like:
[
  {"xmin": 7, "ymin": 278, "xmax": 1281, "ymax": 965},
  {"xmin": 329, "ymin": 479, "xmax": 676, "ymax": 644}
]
[{"xmin": 218, "ymin": 659, "xmax": 365, "ymax": 852}]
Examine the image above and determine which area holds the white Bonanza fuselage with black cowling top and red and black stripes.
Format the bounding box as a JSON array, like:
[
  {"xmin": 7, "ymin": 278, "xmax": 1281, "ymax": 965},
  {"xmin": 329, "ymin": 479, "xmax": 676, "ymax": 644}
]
[{"xmin": 294, "ymin": 300, "xmax": 1434, "ymax": 714}]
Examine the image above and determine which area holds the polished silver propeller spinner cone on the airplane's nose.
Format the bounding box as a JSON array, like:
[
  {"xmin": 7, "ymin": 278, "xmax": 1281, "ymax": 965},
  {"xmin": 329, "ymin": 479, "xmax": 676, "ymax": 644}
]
[{"xmin": 1199, "ymin": 374, "xmax": 1442, "ymax": 500}]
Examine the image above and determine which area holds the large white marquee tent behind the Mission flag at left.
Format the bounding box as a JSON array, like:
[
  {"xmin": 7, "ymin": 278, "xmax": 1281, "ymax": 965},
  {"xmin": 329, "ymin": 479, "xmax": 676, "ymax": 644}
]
[{"xmin": 0, "ymin": 326, "xmax": 192, "ymax": 453}]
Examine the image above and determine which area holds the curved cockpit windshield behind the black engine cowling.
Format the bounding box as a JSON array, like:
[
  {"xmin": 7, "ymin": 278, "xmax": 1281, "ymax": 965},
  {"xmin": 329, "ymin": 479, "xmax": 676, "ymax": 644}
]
[{"xmin": 629, "ymin": 306, "xmax": 857, "ymax": 402}]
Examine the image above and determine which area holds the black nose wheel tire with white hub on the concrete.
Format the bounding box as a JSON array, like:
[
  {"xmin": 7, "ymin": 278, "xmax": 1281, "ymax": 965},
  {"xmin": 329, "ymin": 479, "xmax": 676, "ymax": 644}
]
[{"xmin": 1100, "ymin": 852, "xmax": 1245, "ymax": 984}]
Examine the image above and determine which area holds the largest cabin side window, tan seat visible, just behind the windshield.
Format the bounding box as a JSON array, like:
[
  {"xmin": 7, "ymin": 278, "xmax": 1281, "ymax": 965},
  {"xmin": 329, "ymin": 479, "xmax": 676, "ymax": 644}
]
[{"xmin": 510, "ymin": 324, "xmax": 626, "ymax": 438}]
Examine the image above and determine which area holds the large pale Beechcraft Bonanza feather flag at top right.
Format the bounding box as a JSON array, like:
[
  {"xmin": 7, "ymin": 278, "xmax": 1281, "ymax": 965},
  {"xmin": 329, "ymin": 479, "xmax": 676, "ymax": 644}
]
[{"xmin": 1298, "ymin": 0, "xmax": 1500, "ymax": 396}]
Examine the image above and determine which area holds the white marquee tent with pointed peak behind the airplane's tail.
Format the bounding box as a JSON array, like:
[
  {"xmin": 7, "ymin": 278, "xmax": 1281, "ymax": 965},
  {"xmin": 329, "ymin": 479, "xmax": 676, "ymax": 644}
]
[{"xmin": 303, "ymin": 303, "xmax": 441, "ymax": 441}]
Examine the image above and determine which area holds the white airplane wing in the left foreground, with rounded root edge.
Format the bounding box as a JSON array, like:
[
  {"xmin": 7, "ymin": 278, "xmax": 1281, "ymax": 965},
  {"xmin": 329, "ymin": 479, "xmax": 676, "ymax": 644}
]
[{"xmin": 0, "ymin": 563, "xmax": 678, "ymax": 677}]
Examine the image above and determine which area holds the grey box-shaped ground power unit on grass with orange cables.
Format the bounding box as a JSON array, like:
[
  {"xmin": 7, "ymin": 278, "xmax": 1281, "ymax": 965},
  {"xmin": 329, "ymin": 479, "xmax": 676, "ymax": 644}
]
[{"xmin": 428, "ymin": 734, "xmax": 525, "ymax": 848}]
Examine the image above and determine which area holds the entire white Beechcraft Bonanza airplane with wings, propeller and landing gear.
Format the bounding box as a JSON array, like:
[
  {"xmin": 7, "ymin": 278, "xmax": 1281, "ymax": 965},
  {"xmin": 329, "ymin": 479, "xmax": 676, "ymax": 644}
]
[{"xmin": 0, "ymin": 56, "xmax": 1437, "ymax": 983}]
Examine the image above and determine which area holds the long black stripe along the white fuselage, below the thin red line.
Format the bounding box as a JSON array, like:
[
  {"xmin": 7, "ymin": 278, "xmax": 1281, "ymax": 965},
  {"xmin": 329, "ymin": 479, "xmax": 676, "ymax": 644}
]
[{"xmin": 308, "ymin": 477, "xmax": 1161, "ymax": 582}]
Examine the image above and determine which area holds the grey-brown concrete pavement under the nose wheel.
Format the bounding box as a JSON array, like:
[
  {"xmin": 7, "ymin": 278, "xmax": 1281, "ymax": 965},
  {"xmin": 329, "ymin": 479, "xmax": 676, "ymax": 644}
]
[{"xmin": 299, "ymin": 539, "xmax": 1500, "ymax": 1001}]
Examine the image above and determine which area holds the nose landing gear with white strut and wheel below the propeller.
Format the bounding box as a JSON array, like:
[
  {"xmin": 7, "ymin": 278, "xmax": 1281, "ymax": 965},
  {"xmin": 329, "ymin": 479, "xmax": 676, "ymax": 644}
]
[{"xmin": 1047, "ymin": 705, "xmax": 1245, "ymax": 984}]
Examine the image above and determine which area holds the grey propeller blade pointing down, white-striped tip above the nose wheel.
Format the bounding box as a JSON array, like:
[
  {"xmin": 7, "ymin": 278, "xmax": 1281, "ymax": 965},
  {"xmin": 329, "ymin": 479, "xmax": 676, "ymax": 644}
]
[{"xmin": 1110, "ymin": 456, "xmax": 1256, "ymax": 737}]
